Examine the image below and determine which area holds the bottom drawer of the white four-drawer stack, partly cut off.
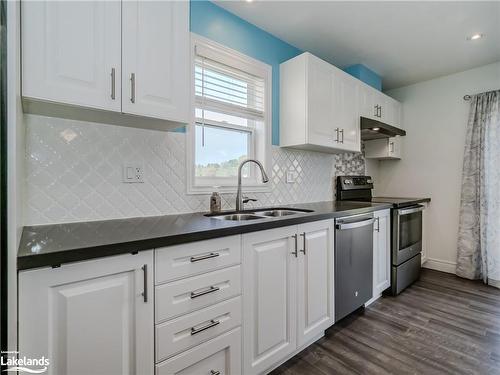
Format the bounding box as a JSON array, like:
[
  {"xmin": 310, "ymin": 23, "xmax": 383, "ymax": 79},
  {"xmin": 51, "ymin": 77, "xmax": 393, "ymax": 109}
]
[{"xmin": 156, "ymin": 328, "xmax": 241, "ymax": 375}]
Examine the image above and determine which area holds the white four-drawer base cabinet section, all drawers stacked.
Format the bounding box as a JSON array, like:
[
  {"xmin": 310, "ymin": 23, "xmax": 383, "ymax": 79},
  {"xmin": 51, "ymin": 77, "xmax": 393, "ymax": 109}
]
[{"xmin": 155, "ymin": 235, "xmax": 242, "ymax": 375}]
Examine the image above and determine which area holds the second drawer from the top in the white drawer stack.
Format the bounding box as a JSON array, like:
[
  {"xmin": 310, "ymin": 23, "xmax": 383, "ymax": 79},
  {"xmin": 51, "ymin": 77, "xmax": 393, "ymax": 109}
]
[{"xmin": 155, "ymin": 265, "xmax": 241, "ymax": 323}]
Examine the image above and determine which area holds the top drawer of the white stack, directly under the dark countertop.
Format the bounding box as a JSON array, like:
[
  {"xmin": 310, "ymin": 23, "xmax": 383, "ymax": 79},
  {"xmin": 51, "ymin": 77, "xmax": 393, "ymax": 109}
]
[{"xmin": 155, "ymin": 236, "xmax": 241, "ymax": 284}]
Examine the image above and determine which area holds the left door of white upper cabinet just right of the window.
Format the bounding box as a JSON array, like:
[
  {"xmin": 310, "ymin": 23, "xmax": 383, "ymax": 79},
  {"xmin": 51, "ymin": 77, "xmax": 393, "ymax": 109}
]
[{"xmin": 307, "ymin": 55, "xmax": 337, "ymax": 147}]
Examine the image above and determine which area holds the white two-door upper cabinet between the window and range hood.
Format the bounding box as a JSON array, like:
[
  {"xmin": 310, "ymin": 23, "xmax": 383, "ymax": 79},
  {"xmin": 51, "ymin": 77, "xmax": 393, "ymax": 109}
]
[{"xmin": 280, "ymin": 52, "xmax": 360, "ymax": 153}]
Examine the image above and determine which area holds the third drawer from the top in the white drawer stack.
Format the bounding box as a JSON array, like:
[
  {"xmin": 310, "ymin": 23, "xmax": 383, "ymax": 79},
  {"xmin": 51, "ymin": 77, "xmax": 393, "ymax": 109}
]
[{"xmin": 156, "ymin": 297, "xmax": 241, "ymax": 361}]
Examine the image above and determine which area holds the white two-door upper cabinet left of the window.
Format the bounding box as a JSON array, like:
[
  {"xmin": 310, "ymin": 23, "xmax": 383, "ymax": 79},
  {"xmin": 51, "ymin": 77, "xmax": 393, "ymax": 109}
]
[{"xmin": 21, "ymin": 1, "xmax": 191, "ymax": 129}]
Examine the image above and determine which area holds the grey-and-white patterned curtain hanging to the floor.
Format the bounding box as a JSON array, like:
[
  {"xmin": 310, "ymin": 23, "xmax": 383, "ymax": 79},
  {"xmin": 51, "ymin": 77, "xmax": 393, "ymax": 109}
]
[{"xmin": 457, "ymin": 90, "xmax": 500, "ymax": 287}]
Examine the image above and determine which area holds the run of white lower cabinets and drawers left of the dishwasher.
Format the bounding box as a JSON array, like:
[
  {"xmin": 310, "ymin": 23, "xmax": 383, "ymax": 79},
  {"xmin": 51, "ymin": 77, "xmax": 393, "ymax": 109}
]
[{"xmin": 19, "ymin": 220, "xmax": 338, "ymax": 375}]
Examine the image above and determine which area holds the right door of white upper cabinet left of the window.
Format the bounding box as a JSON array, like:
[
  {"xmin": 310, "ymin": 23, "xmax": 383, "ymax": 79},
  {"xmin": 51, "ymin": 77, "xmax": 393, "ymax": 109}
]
[{"xmin": 122, "ymin": 1, "xmax": 191, "ymax": 123}]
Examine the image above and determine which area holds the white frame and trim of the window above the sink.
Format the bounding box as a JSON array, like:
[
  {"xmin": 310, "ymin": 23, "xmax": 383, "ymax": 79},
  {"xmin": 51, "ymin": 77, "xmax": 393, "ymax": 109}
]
[{"xmin": 186, "ymin": 33, "xmax": 272, "ymax": 194}]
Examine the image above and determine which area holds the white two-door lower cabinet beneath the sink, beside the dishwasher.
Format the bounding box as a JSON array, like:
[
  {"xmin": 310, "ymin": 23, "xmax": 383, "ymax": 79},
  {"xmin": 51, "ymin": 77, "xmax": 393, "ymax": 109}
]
[{"xmin": 242, "ymin": 220, "xmax": 334, "ymax": 374}]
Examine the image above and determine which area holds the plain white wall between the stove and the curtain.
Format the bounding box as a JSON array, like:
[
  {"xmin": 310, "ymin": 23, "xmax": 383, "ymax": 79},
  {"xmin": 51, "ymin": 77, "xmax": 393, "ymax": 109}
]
[{"xmin": 376, "ymin": 62, "xmax": 500, "ymax": 273}]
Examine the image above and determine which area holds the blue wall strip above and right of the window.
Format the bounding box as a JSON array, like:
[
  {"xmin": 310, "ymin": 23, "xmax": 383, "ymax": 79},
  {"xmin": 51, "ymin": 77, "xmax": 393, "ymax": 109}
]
[{"xmin": 190, "ymin": 0, "xmax": 302, "ymax": 145}]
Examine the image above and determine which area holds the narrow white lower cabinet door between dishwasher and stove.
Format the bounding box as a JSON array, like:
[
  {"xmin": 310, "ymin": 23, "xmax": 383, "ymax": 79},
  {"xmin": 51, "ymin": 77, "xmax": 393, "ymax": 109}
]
[{"xmin": 373, "ymin": 210, "xmax": 391, "ymax": 297}]
